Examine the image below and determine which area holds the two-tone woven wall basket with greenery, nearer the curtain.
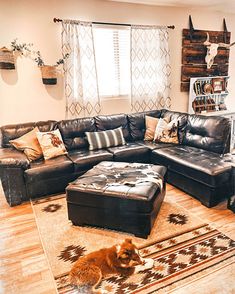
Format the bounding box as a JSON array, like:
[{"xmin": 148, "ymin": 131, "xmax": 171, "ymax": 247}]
[{"xmin": 34, "ymin": 51, "xmax": 69, "ymax": 85}]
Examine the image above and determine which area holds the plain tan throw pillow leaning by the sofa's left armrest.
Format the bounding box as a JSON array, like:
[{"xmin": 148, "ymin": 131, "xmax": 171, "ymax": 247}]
[{"xmin": 10, "ymin": 127, "xmax": 42, "ymax": 161}]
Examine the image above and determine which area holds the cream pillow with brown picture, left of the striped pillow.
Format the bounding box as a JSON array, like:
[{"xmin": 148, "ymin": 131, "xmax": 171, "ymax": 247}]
[{"xmin": 37, "ymin": 130, "xmax": 67, "ymax": 159}]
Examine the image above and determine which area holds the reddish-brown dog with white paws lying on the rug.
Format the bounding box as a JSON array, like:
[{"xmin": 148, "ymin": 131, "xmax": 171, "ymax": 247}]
[{"xmin": 69, "ymin": 239, "xmax": 154, "ymax": 293}]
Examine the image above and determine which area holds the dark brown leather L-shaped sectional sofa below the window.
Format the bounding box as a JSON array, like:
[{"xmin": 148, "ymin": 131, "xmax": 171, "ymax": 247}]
[{"xmin": 0, "ymin": 109, "xmax": 231, "ymax": 207}]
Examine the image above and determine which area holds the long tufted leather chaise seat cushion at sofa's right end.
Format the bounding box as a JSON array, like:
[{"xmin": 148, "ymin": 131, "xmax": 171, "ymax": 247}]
[{"xmin": 152, "ymin": 145, "xmax": 231, "ymax": 186}]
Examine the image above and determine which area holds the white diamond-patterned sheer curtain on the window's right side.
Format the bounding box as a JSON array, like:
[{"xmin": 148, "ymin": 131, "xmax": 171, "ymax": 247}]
[{"xmin": 131, "ymin": 26, "xmax": 171, "ymax": 112}]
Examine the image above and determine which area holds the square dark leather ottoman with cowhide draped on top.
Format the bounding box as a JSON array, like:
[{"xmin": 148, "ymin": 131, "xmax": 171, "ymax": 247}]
[{"xmin": 66, "ymin": 161, "xmax": 166, "ymax": 238}]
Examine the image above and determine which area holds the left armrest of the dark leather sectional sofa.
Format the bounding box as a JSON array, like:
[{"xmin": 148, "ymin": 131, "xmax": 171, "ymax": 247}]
[{"xmin": 0, "ymin": 148, "xmax": 30, "ymax": 206}]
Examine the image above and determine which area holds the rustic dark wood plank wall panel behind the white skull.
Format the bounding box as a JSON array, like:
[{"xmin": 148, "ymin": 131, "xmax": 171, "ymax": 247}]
[{"xmin": 181, "ymin": 29, "xmax": 231, "ymax": 92}]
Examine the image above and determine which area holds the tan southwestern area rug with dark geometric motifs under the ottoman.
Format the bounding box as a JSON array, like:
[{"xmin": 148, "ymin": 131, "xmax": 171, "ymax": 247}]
[{"xmin": 32, "ymin": 195, "xmax": 235, "ymax": 294}]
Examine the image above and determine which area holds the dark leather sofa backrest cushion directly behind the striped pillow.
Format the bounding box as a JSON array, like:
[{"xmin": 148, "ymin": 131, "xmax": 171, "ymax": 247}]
[{"xmin": 95, "ymin": 114, "xmax": 131, "ymax": 141}]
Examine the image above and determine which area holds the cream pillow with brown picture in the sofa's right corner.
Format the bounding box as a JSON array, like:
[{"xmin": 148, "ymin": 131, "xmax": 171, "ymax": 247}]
[{"xmin": 154, "ymin": 118, "xmax": 179, "ymax": 144}]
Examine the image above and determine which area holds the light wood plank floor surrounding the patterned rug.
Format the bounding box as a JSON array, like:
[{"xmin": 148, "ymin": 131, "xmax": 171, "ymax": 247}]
[{"xmin": 0, "ymin": 185, "xmax": 235, "ymax": 294}]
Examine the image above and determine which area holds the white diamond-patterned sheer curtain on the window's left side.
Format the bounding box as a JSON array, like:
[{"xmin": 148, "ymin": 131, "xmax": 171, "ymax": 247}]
[{"xmin": 62, "ymin": 20, "xmax": 101, "ymax": 118}]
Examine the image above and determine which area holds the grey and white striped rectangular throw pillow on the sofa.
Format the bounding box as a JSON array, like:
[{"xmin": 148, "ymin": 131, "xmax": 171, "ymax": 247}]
[{"xmin": 86, "ymin": 127, "xmax": 126, "ymax": 150}]
